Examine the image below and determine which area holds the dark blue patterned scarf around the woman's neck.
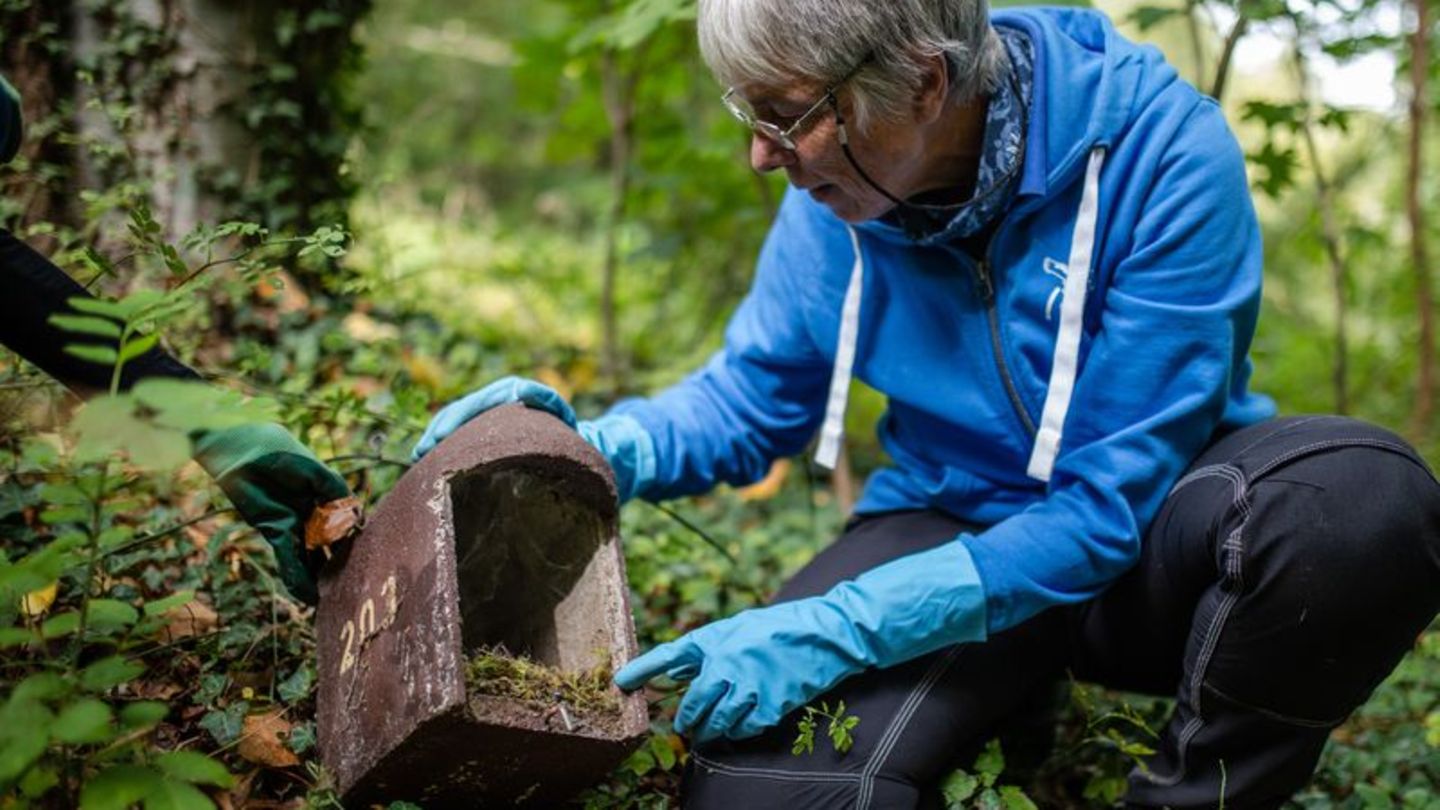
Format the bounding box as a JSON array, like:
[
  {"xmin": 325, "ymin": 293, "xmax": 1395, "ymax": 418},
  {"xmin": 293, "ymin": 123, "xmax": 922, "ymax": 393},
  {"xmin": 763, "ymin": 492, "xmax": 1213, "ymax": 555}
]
[{"xmin": 886, "ymin": 27, "xmax": 1035, "ymax": 244}]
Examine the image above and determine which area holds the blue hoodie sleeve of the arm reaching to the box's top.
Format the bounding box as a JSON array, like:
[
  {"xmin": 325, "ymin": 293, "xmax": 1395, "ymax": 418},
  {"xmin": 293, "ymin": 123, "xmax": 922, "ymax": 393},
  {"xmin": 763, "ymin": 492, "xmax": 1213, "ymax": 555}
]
[{"xmin": 611, "ymin": 195, "xmax": 850, "ymax": 500}]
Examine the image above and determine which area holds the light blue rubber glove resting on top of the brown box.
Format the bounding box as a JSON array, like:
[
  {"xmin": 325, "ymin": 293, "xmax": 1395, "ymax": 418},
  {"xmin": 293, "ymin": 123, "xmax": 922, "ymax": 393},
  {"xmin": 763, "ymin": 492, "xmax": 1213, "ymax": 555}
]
[{"xmin": 410, "ymin": 376, "xmax": 655, "ymax": 503}]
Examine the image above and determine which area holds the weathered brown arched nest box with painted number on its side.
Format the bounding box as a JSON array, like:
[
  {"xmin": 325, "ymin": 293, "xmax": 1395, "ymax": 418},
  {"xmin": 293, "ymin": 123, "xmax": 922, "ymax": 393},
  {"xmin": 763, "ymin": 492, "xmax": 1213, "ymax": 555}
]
[{"xmin": 315, "ymin": 405, "xmax": 648, "ymax": 807}]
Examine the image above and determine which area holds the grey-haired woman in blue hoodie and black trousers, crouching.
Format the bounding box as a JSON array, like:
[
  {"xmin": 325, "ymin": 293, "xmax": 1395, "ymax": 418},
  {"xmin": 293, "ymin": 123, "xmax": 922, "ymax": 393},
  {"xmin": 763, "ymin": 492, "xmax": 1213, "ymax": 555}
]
[{"xmin": 416, "ymin": 0, "xmax": 1440, "ymax": 810}]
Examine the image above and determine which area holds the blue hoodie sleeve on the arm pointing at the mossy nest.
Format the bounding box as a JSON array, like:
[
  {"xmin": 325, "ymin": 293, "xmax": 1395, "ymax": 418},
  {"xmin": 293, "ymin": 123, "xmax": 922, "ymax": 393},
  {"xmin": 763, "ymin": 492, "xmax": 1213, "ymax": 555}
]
[{"xmin": 962, "ymin": 101, "xmax": 1261, "ymax": 633}]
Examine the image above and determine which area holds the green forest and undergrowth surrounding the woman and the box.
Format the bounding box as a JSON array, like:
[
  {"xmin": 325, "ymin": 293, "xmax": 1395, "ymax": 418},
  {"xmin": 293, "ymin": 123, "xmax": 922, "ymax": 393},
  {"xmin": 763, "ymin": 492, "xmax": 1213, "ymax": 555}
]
[{"xmin": 0, "ymin": 0, "xmax": 1440, "ymax": 809}]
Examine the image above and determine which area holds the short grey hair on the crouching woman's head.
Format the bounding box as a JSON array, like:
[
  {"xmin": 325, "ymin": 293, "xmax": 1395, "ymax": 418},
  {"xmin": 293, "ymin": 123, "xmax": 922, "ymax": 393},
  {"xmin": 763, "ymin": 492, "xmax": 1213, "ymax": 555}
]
[{"xmin": 697, "ymin": 0, "xmax": 1007, "ymax": 130}]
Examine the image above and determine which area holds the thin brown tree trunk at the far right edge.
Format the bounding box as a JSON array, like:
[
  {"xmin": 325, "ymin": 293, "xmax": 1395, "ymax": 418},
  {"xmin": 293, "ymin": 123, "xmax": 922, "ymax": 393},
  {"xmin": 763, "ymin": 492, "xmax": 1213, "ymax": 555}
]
[{"xmin": 1405, "ymin": 0, "xmax": 1436, "ymax": 437}]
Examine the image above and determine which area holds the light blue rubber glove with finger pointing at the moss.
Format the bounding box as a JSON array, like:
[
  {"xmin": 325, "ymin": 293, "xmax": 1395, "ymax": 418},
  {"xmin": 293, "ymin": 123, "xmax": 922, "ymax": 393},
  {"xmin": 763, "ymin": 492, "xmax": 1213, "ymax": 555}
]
[{"xmin": 615, "ymin": 539, "xmax": 985, "ymax": 742}]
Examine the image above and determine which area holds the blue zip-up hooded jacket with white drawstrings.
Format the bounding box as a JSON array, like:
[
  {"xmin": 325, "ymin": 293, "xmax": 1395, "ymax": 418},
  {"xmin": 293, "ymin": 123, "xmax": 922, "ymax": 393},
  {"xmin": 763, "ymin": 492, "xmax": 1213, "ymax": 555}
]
[{"xmin": 618, "ymin": 7, "xmax": 1274, "ymax": 633}]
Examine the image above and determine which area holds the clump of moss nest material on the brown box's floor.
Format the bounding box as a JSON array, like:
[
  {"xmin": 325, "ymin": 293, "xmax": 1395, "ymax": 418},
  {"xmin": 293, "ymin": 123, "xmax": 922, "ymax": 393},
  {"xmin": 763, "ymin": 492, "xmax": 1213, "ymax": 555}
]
[{"xmin": 465, "ymin": 646, "xmax": 621, "ymax": 713}]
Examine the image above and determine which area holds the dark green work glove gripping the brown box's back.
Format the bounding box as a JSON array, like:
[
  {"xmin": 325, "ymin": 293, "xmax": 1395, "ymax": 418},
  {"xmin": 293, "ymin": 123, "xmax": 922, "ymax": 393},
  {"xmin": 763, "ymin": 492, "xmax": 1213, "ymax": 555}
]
[{"xmin": 194, "ymin": 424, "xmax": 350, "ymax": 605}]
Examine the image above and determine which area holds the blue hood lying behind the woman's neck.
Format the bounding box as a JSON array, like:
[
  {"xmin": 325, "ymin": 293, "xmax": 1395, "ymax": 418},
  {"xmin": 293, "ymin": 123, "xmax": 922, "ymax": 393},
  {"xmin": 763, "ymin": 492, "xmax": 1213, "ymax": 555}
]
[{"xmin": 857, "ymin": 7, "xmax": 1176, "ymax": 244}]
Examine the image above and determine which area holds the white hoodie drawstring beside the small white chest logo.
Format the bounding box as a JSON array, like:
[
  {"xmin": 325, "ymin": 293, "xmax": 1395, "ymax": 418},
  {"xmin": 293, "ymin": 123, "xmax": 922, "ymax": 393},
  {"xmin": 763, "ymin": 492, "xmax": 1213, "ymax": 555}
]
[{"xmin": 1025, "ymin": 147, "xmax": 1104, "ymax": 481}]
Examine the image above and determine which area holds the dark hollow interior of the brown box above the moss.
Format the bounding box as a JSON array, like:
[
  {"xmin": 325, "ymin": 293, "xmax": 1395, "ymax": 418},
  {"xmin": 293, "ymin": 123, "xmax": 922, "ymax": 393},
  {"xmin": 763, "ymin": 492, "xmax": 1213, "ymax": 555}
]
[{"xmin": 449, "ymin": 468, "xmax": 610, "ymax": 672}]
